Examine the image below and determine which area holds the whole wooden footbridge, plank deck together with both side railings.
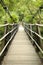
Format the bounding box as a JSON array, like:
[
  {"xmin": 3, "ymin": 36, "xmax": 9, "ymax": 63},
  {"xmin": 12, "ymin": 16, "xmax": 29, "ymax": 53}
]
[{"xmin": 0, "ymin": 23, "xmax": 43, "ymax": 65}]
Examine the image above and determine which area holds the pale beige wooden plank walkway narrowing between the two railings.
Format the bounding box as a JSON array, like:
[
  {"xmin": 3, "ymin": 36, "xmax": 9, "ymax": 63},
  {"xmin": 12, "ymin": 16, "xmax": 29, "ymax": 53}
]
[{"xmin": 2, "ymin": 25, "xmax": 42, "ymax": 65}]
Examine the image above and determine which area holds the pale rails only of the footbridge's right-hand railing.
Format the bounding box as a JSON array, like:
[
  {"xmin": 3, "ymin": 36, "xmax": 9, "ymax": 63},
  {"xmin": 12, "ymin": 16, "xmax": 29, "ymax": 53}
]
[{"xmin": 24, "ymin": 23, "xmax": 43, "ymax": 54}]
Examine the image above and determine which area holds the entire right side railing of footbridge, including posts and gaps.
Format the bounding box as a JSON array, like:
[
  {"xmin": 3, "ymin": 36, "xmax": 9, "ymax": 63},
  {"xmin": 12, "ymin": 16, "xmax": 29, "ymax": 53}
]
[{"xmin": 23, "ymin": 23, "xmax": 43, "ymax": 56}]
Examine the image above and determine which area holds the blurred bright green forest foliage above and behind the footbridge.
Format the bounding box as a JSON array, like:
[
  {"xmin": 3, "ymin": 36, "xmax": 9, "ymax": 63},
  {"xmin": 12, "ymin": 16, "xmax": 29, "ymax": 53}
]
[{"xmin": 0, "ymin": 0, "xmax": 43, "ymax": 24}]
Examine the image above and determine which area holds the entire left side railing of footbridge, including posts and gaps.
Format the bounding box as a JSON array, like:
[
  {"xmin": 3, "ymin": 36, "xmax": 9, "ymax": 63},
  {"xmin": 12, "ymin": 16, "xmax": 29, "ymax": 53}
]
[{"xmin": 0, "ymin": 23, "xmax": 18, "ymax": 57}]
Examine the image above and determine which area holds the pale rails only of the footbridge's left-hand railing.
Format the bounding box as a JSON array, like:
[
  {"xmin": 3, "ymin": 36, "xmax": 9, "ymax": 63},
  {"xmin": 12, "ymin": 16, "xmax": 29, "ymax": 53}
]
[{"xmin": 0, "ymin": 23, "xmax": 18, "ymax": 57}]
